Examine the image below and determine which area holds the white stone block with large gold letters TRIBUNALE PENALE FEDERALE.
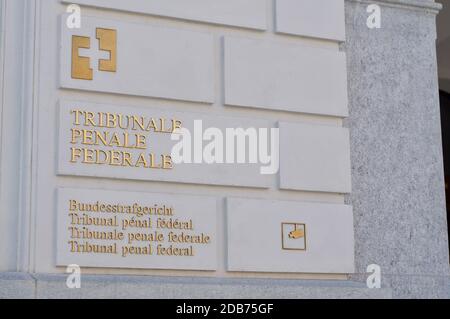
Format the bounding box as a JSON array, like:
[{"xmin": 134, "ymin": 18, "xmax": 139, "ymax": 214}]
[{"xmin": 57, "ymin": 101, "xmax": 276, "ymax": 188}]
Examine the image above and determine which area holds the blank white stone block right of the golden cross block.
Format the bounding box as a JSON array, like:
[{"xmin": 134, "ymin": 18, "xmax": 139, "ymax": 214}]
[{"xmin": 225, "ymin": 37, "xmax": 348, "ymax": 117}]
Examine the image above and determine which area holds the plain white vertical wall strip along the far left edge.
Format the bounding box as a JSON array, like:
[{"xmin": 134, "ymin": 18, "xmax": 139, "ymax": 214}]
[{"xmin": 0, "ymin": 1, "xmax": 34, "ymax": 271}]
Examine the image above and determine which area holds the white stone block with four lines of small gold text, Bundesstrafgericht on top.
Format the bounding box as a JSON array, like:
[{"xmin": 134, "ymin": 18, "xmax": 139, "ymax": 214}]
[{"xmin": 56, "ymin": 189, "xmax": 217, "ymax": 270}]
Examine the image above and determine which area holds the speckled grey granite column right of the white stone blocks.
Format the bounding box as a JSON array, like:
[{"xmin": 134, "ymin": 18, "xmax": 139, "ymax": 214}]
[{"xmin": 345, "ymin": 0, "xmax": 450, "ymax": 298}]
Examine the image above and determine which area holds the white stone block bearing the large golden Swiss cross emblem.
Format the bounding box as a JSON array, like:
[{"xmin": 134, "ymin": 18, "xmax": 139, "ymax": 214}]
[{"xmin": 60, "ymin": 16, "xmax": 214, "ymax": 103}]
